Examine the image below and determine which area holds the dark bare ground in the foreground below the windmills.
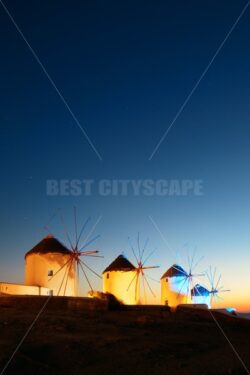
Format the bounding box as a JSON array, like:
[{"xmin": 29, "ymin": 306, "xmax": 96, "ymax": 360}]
[{"xmin": 0, "ymin": 297, "xmax": 250, "ymax": 375}]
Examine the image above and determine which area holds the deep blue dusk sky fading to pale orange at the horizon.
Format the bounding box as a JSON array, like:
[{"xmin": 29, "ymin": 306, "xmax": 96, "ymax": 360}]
[{"xmin": 0, "ymin": 0, "xmax": 250, "ymax": 305}]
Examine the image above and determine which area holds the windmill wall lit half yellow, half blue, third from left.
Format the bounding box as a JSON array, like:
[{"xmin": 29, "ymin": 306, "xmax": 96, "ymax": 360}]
[{"xmin": 161, "ymin": 276, "xmax": 190, "ymax": 307}]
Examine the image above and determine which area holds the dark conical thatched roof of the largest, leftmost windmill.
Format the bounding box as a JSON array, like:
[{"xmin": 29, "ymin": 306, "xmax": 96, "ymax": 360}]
[{"xmin": 25, "ymin": 235, "xmax": 71, "ymax": 258}]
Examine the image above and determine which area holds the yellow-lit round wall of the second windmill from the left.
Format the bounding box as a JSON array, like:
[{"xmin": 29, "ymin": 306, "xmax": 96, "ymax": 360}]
[{"xmin": 102, "ymin": 271, "xmax": 140, "ymax": 305}]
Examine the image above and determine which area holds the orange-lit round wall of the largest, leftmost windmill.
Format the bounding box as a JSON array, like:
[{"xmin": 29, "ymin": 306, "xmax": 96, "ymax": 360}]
[{"xmin": 25, "ymin": 253, "xmax": 76, "ymax": 296}]
